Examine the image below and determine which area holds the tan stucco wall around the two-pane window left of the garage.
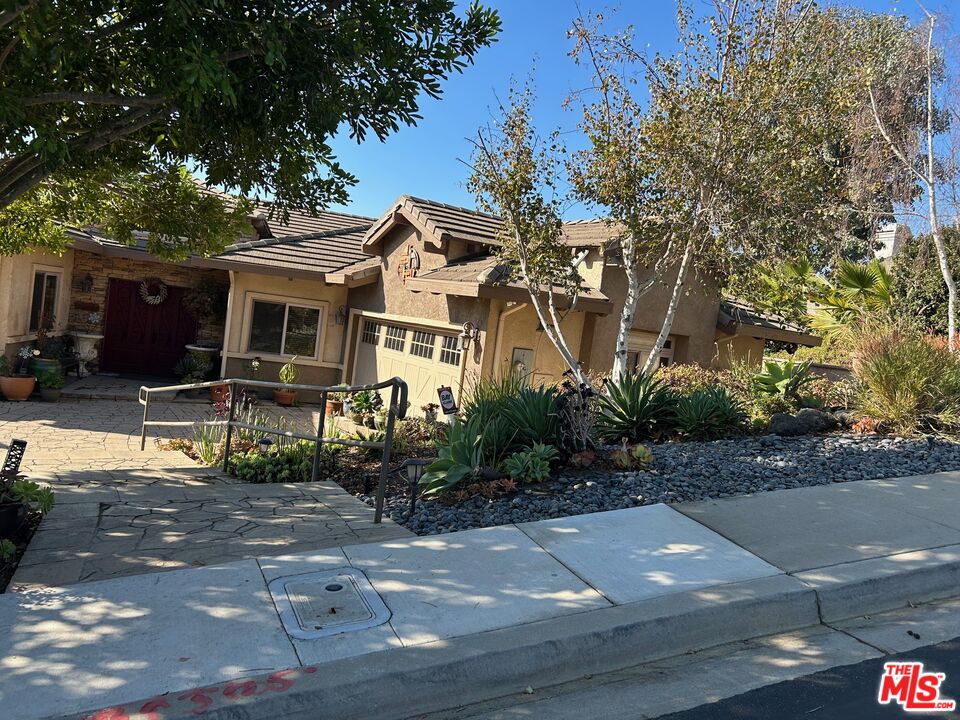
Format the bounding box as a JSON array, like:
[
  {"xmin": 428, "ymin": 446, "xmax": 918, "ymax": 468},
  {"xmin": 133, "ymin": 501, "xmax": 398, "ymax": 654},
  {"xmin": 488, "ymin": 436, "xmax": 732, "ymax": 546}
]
[{"xmin": 225, "ymin": 272, "xmax": 347, "ymax": 385}]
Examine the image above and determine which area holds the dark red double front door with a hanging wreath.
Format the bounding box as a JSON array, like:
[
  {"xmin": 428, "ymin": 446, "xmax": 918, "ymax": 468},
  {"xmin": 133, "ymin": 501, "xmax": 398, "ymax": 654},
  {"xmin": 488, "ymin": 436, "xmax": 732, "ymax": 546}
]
[{"xmin": 100, "ymin": 278, "xmax": 197, "ymax": 377}]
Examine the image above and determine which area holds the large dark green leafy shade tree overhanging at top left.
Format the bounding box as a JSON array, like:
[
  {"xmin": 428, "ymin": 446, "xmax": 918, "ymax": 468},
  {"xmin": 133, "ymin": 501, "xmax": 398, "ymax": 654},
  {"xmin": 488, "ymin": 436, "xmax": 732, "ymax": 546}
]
[{"xmin": 0, "ymin": 0, "xmax": 500, "ymax": 258}]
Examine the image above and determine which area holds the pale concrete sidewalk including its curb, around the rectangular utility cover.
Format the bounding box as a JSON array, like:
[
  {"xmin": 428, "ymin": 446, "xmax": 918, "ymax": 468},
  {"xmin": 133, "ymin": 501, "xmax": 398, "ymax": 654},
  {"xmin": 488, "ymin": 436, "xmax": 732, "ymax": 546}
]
[{"xmin": 0, "ymin": 473, "xmax": 960, "ymax": 720}]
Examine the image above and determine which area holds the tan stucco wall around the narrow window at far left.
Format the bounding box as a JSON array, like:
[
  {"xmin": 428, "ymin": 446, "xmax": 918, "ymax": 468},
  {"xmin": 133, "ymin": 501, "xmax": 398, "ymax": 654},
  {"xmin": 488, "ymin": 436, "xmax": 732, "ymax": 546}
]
[{"xmin": 0, "ymin": 250, "xmax": 73, "ymax": 354}]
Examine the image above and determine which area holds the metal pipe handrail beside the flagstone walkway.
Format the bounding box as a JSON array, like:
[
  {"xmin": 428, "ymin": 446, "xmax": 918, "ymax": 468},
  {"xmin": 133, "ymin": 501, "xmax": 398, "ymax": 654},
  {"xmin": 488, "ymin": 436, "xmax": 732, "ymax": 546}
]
[{"xmin": 137, "ymin": 377, "xmax": 407, "ymax": 523}]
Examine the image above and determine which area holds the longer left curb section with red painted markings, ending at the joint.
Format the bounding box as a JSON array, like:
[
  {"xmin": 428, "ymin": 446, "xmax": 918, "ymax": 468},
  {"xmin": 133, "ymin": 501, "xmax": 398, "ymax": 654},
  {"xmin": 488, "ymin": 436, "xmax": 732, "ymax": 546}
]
[{"xmin": 60, "ymin": 575, "xmax": 820, "ymax": 720}]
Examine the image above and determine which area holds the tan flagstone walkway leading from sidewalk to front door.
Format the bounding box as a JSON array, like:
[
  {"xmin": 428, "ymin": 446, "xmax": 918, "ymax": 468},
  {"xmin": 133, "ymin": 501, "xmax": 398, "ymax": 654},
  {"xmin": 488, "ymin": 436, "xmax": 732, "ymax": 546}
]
[{"xmin": 0, "ymin": 400, "xmax": 411, "ymax": 591}]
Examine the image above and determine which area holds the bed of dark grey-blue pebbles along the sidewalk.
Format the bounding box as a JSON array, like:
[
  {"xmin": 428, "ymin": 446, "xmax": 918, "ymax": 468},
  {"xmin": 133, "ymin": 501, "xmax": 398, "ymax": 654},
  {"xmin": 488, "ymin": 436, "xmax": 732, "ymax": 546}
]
[{"xmin": 360, "ymin": 435, "xmax": 960, "ymax": 535}]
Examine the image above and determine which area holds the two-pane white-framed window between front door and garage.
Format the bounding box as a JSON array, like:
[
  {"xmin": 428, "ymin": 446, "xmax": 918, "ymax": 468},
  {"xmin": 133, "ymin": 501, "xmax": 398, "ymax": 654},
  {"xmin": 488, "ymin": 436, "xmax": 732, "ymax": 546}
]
[{"xmin": 247, "ymin": 300, "xmax": 322, "ymax": 358}]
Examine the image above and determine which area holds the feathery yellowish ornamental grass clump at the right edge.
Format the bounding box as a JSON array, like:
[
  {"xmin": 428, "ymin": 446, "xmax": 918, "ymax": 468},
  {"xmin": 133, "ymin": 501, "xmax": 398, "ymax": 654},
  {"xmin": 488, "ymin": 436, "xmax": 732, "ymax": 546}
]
[{"xmin": 854, "ymin": 324, "xmax": 960, "ymax": 435}]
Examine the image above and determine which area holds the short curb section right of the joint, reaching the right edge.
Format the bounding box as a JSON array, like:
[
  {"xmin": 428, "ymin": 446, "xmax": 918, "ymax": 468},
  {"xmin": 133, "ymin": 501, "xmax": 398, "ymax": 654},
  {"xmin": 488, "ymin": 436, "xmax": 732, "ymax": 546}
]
[{"xmin": 793, "ymin": 545, "xmax": 960, "ymax": 622}]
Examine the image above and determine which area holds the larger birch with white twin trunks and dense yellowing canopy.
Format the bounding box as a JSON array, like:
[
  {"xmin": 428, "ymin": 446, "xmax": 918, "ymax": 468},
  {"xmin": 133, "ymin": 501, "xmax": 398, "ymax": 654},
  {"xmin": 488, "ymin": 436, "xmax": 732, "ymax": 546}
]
[{"xmin": 573, "ymin": 0, "xmax": 916, "ymax": 373}]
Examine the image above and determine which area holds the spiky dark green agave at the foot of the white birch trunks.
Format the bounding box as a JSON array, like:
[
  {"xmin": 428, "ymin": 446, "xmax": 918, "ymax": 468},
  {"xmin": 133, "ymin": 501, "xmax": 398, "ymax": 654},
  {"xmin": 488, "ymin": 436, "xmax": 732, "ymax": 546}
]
[{"xmin": 595, "ymin": 374, "xmax": 678, "ymax": 442}]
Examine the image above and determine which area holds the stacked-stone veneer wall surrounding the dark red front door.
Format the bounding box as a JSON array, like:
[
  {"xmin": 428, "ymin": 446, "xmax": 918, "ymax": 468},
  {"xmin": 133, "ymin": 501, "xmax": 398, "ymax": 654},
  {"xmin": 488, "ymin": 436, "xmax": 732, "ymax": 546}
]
[{"xmin": 69, "ymin": 250, "xmax": 230, "ymax": 347}]
